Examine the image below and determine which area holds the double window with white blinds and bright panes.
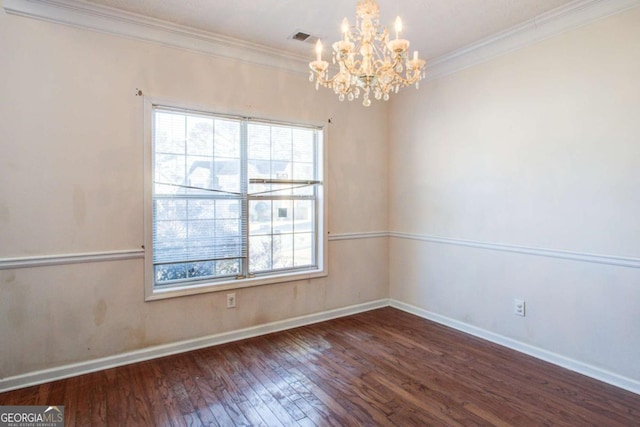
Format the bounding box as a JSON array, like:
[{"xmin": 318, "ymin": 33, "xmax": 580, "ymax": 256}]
[{"xmin": 145, "ymin": 105, "xmax": 325, "ymax": 299}]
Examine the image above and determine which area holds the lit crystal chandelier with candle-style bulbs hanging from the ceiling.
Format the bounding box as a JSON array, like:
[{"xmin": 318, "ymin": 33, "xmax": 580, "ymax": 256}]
[{"xmin": 309, "ymin": 0, "xmax": 425, "ymax": 107}]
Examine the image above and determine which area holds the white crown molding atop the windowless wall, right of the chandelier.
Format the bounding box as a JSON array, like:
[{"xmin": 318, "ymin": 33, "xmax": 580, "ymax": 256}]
[{"xmin": 425, "ymin": 0, "xmax": 640, "ymax": 81}]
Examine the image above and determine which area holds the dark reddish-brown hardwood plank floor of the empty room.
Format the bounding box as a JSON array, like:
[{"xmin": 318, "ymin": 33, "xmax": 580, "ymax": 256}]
[{"xmin": 0, "ymin": 308, "xmax": 640, "ymax": 427}]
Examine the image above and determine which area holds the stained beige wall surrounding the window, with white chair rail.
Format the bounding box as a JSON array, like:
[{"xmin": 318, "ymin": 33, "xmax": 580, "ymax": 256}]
[{"xmin": 0, "ymin": 9, "xmax": 388, "ymax": 378}]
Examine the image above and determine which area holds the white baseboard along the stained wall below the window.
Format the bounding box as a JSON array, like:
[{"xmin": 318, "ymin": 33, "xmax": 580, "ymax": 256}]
[{"xmin": 0, "ymin": 299, "xmax": 389, "ymax": 392}]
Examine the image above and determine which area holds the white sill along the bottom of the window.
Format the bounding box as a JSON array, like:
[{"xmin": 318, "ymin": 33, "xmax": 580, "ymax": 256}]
[{"xmin": 145, "ymin": 269, "xmax": 328, "ymax": 301}]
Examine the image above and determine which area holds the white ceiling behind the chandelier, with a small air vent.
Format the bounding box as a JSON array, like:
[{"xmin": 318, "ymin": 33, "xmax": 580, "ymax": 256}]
[{"xmin": 80, "ymin": 0, "xmax": 582, "ymax": 60}]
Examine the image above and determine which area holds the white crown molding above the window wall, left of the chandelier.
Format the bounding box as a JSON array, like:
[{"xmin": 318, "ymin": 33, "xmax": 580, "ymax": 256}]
[{"xmin": 4, "ymin": 0, "xmax": 309, "ymax": 73}]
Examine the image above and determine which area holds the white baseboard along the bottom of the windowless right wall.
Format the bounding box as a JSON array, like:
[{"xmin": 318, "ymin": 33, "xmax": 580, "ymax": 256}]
[{"xmin": 389, "ymin": 299, "xmax": 640, "ymax": 394}]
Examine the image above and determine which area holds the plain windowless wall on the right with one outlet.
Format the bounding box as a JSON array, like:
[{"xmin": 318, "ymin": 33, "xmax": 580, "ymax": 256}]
[{"xmin": 389, "ymin": 8, "xmax": 640, "ymax": 384}]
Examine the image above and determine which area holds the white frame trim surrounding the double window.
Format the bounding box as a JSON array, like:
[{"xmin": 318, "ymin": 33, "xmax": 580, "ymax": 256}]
[{"xmin": 143, "ymin": 97, "xmax": 328, "ymax": 301}]
